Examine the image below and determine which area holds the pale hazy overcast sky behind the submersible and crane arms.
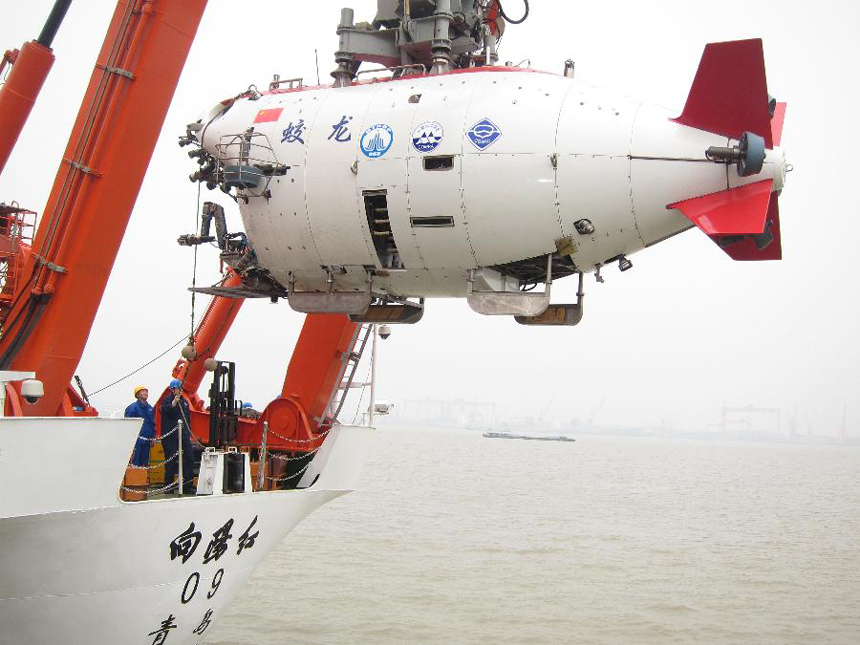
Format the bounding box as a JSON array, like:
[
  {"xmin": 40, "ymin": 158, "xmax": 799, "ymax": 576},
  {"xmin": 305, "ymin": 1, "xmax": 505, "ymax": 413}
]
[{"xmin": 0, "ymin": 0, "xmax": 860, "ymax": 434}]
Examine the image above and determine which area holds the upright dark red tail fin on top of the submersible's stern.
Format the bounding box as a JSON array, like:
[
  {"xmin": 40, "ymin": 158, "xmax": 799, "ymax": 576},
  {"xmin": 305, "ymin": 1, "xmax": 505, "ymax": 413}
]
[{"xmin": 673, "ymin": 38, "xmax": 774, "ymax": 148}]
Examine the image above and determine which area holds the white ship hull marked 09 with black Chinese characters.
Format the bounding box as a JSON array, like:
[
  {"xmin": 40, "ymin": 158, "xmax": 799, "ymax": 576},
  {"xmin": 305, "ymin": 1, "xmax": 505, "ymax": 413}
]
[{"xmin": 0, "ymin": 419, "xmax": 369, "ymax": 644}]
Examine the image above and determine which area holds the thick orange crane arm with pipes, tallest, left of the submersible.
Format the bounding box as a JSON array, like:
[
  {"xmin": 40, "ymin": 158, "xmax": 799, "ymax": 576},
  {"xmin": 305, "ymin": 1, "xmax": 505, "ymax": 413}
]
[{"xmin": 0, "ymin": 0, "xmax": 206, "ymax": 416}]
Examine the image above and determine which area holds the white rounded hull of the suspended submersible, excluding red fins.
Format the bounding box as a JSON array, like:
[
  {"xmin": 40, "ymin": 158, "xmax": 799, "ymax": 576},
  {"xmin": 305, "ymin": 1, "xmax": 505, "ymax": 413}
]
[{"xmin": 198, "ymin": 68, "xmax": 785, "ymax": 296}]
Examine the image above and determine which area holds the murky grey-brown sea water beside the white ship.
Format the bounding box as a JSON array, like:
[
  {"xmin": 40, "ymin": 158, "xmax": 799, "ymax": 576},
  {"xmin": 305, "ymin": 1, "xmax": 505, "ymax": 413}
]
[{"xmin": 204, "ymin": 427, "xmax": 860, "ymax": 645}]
